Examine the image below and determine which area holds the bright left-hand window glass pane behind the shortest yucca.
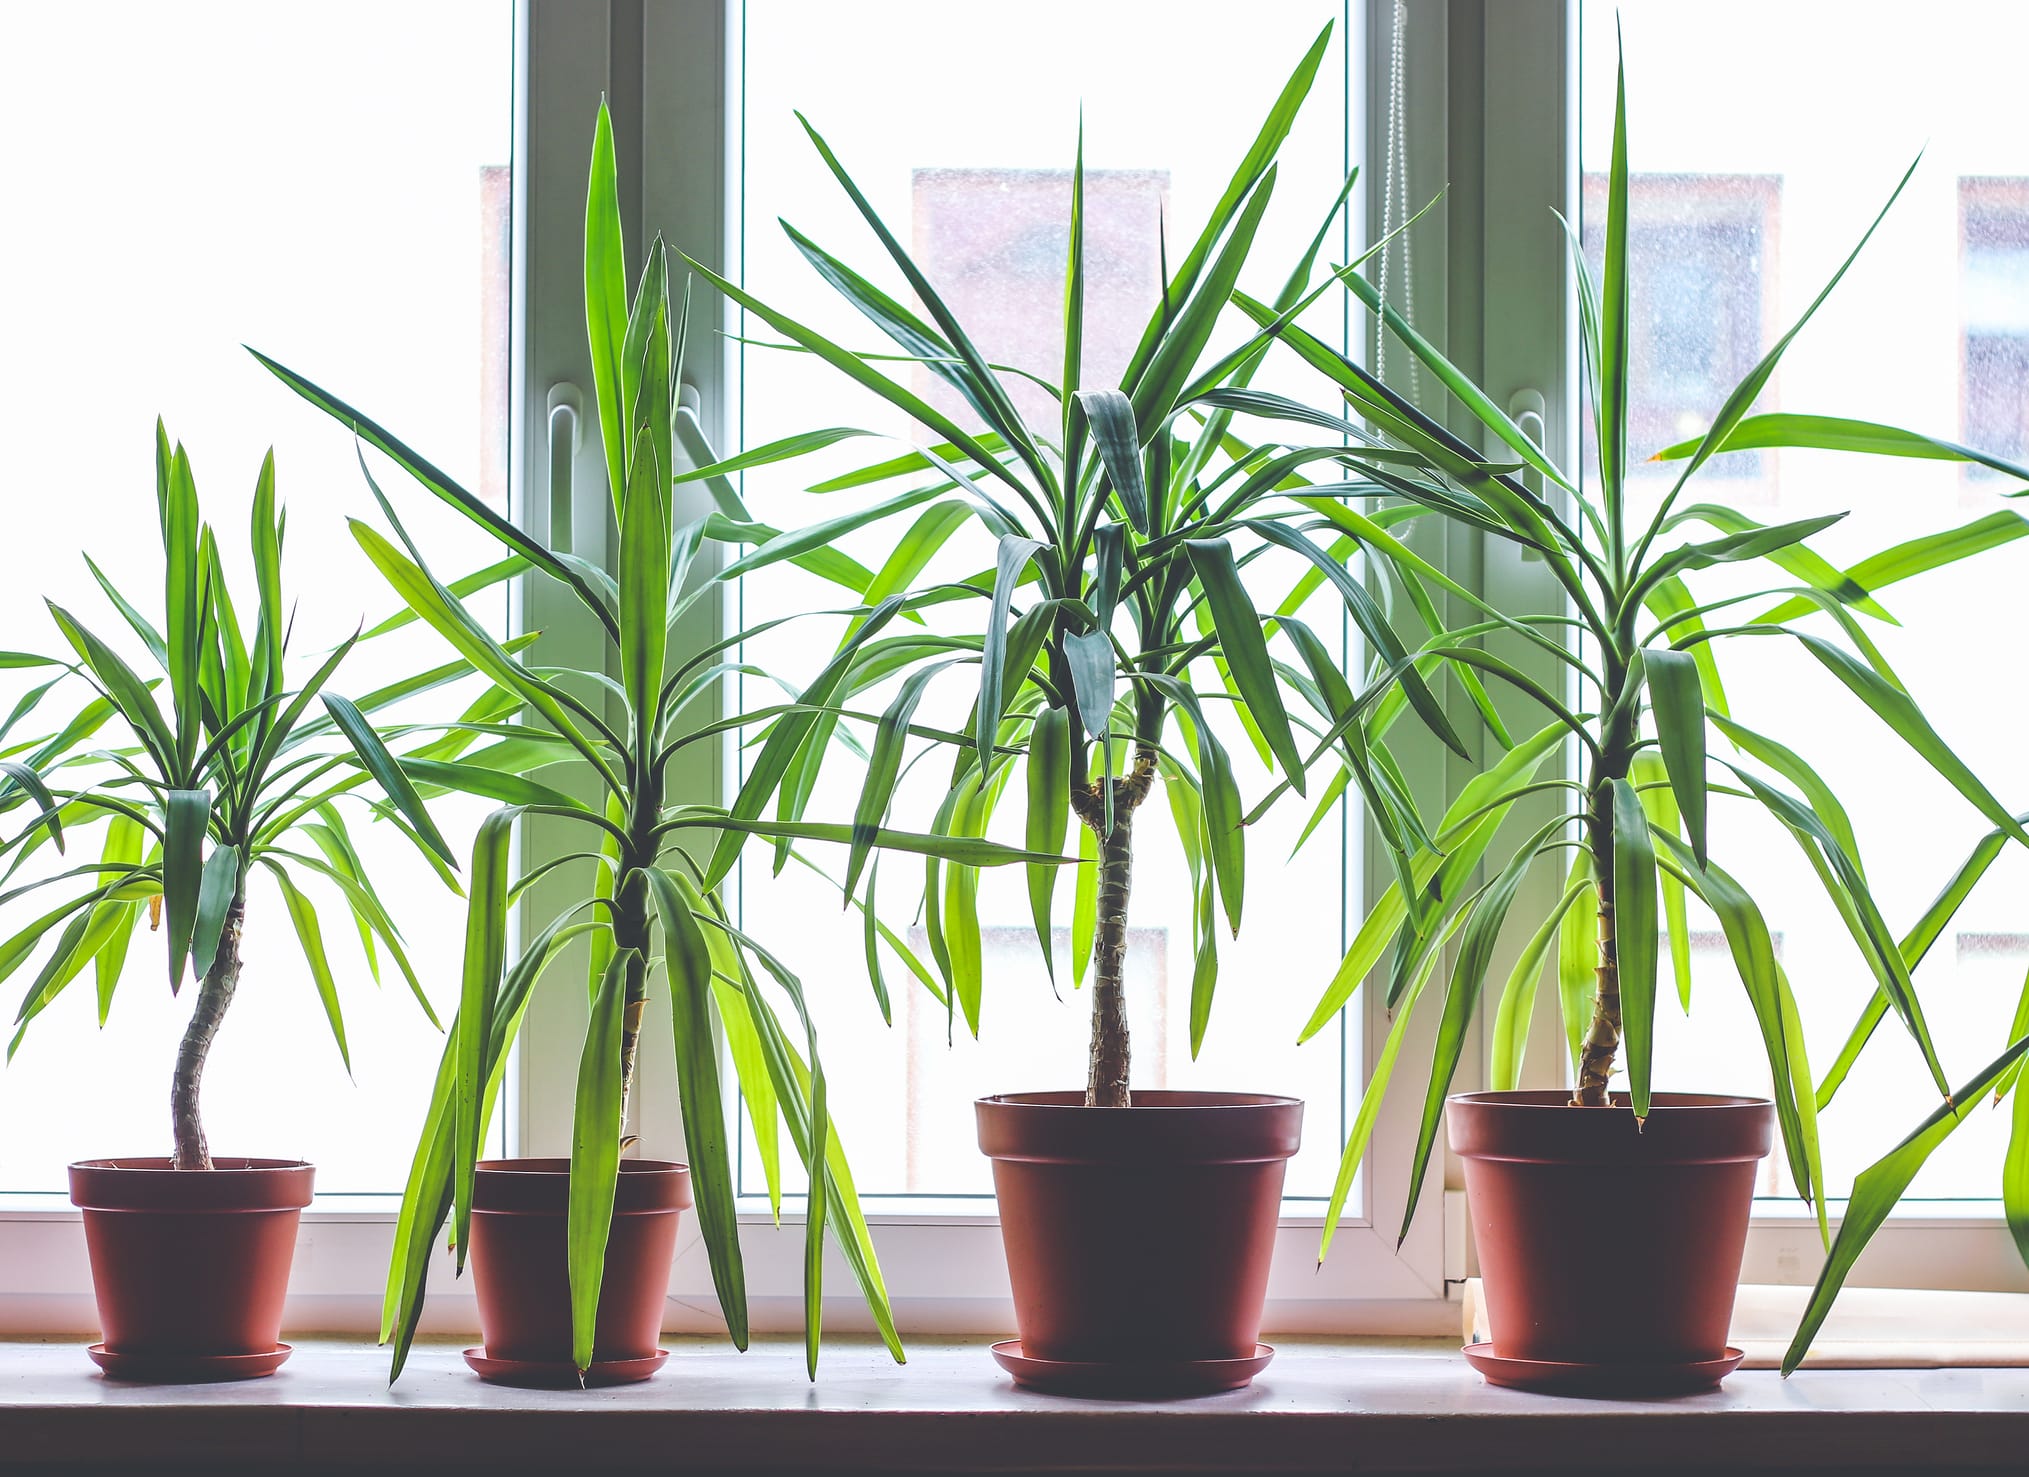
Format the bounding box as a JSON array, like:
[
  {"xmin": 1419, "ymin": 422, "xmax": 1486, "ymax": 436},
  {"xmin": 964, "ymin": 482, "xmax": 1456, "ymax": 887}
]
[{"xmin": 0, "ymin": 0, "xmax": 513, "ymax": 1193}]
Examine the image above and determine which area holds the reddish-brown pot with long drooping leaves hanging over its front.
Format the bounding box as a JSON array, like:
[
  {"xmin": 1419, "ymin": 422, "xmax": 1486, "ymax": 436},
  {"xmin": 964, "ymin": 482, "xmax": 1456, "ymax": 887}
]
[{"xmin": 467, "ymin": 1158, "xmax": 692, "ymax": 1386}]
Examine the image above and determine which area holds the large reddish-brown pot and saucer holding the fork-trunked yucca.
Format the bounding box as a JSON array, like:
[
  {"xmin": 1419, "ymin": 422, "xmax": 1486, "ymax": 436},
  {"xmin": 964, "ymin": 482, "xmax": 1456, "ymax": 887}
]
[{"xmin": 974, "ymin": 1092, "xmax": 1303, "ymax": 1394}]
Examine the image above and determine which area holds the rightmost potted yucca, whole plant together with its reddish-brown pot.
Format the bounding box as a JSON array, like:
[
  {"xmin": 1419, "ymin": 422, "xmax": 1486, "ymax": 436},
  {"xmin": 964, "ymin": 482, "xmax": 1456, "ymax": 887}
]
[{"xmin": 1266, "ymin": 37, "xmax": 2029, "ymax": 1390}]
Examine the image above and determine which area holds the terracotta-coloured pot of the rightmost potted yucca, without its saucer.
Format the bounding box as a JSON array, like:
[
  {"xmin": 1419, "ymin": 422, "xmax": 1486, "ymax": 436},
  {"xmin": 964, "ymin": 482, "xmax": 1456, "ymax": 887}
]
[{"xmin": 1447, "ymin": 1092, "xmax": 1775, "ymax": 1365}]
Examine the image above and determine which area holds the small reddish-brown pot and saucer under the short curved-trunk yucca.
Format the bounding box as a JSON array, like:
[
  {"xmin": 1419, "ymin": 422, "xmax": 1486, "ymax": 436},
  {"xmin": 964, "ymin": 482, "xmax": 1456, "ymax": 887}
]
[{"xmin": 71, "ymin": 1158, "xmax": 317, "ymax": 1382}]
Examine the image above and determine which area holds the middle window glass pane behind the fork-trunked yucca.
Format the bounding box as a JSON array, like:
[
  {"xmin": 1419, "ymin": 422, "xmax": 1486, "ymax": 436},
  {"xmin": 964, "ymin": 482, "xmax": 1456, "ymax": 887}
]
[{"xmin": 732, "ymin": 0, "xmax": 1359, "ymax": 1209}]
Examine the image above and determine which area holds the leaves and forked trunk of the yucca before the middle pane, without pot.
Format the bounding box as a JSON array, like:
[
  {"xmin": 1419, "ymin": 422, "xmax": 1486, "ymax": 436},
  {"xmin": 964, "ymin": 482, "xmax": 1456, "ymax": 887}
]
[{"xmin": 677, "ymin": 26, "xmax": 1459, "ymax": 1106}]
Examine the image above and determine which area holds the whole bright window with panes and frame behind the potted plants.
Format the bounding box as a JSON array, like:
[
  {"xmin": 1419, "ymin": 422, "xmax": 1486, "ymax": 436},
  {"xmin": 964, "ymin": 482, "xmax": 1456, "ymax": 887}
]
[{"xmin": 0, "ymin": 0, "xmax": 2029, "ymax": 1333}]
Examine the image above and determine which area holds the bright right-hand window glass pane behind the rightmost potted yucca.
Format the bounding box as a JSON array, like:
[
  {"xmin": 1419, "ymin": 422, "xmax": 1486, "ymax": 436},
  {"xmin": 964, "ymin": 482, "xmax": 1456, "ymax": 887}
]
[{"xmin": 1583, "ymin": 0, "xmax": 2029, "ymax": 1199}]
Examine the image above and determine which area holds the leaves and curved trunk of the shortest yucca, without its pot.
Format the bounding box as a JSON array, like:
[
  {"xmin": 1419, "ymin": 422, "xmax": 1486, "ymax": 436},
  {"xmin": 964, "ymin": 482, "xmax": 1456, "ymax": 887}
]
[{"xmin": 0, "ymin": 422, "xmax": 470, "ymax": 1171}]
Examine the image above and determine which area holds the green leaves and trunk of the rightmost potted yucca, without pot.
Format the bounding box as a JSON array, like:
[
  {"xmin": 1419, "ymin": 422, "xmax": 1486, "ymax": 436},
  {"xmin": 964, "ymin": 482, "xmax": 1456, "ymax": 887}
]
[{"xmin": 1266, "ymin": 37, "xmax": 2029, "ymax": 1367}]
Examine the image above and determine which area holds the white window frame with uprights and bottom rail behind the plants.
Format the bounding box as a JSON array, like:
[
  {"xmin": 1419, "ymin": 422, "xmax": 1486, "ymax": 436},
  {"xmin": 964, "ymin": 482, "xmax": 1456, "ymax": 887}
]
[{"xmin": 0, "ymin": 0, "xmax": 2029, "ymax": 1335}]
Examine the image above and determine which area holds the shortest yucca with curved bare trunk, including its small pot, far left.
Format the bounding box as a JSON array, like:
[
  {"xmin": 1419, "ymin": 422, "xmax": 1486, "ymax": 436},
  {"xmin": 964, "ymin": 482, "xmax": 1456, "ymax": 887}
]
[{"xmin": 0, "ymin": 424, "xmax": 473, "ymax": 1380}]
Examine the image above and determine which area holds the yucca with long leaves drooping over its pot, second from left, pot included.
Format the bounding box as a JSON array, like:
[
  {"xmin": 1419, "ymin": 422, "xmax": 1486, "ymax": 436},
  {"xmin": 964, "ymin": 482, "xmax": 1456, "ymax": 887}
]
[{"xmin": 256, "ymin": 106, "xmax": 1063, "ymax": 1384}]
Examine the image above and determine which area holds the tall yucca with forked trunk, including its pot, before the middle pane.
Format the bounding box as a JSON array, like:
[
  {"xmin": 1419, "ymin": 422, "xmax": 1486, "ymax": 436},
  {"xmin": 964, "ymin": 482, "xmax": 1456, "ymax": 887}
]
[{"xmin": 681, "ymin": 26, "xmax": 1459, "ymax": 1394}]
